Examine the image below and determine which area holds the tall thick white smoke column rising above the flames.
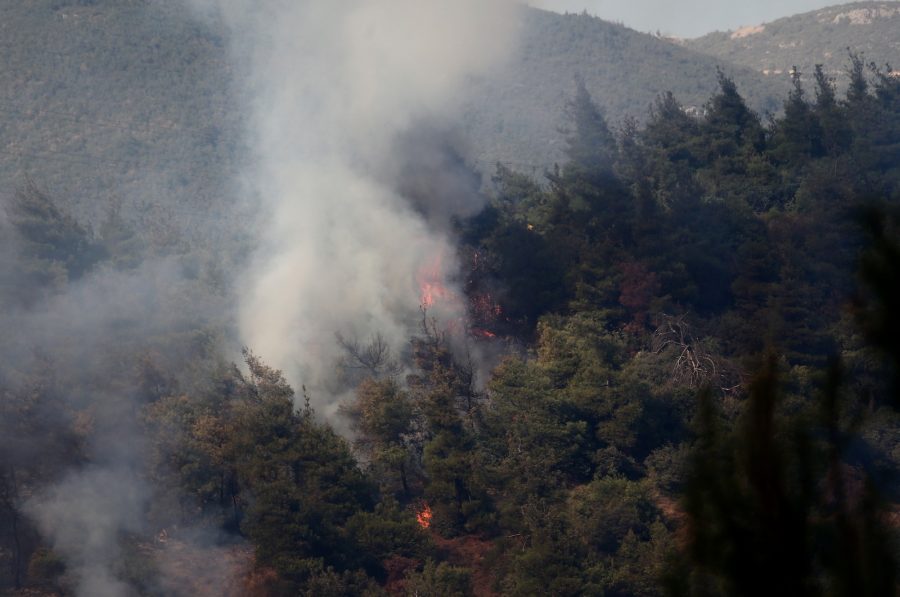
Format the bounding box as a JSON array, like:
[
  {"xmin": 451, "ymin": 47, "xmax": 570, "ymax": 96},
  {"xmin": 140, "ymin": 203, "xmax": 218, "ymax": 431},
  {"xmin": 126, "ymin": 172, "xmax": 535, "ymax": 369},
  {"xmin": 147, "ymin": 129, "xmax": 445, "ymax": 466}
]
[{"xmin": 195, "ymin": 0, "xmax": 517, "ymax": 406}]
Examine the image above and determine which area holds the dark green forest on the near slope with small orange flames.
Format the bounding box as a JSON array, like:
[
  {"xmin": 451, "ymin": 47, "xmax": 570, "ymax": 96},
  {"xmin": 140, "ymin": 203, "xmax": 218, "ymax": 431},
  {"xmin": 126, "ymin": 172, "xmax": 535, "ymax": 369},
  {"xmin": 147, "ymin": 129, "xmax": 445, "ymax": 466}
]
[{"xmin": 0, "ymin": 55, "xmax": 900, "ymax": 596}]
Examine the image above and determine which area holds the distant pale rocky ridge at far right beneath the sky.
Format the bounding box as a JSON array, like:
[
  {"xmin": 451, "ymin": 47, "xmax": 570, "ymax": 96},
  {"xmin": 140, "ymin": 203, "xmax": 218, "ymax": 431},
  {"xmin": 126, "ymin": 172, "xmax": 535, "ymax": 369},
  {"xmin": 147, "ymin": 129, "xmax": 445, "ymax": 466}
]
[{"xmin": 682, "ymin": 2, "xmax": 900, "ymax": 84}]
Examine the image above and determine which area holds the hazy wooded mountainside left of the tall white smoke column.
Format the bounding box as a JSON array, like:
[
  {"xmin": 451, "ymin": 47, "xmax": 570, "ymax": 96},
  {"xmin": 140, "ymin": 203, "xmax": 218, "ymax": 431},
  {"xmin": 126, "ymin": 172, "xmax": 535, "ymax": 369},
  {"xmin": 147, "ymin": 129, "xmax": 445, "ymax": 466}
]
[{"xmin": 0, "ymin": 0, "xmax": 241, "ymax": 236}]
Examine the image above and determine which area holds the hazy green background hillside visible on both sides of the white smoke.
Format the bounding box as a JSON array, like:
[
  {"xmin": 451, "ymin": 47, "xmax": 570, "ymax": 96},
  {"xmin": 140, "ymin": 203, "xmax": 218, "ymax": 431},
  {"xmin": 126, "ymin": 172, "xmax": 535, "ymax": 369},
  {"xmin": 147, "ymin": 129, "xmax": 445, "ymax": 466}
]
[{"xmin": 0, "ymin": 0, "xmax": 786, "ymax": 237}]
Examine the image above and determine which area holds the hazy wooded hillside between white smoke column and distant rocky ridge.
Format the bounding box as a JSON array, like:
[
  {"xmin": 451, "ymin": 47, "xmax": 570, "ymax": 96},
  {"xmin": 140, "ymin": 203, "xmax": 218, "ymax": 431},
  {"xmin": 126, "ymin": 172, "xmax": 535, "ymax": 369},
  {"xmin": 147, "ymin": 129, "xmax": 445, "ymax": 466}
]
[{"xmin": 467, "ymin": 10, "xmax": 789, "ymax": 171}]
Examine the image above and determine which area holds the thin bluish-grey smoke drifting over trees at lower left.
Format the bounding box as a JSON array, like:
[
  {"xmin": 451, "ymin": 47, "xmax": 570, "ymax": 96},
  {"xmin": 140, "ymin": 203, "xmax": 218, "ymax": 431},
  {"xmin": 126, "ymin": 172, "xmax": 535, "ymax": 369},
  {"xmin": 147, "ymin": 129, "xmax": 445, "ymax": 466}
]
[{"xmin": 0, "ymin": 253, "xmax": 227, "ymax": 597}]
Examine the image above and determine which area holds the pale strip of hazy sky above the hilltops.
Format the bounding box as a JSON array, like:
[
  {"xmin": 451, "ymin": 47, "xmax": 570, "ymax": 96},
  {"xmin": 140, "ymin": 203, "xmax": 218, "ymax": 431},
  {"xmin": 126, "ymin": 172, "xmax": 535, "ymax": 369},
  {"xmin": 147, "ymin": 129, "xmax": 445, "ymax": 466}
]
[{"xmin": 531, "ymin": 0, "xmax": 846, "ymax": 37}]
